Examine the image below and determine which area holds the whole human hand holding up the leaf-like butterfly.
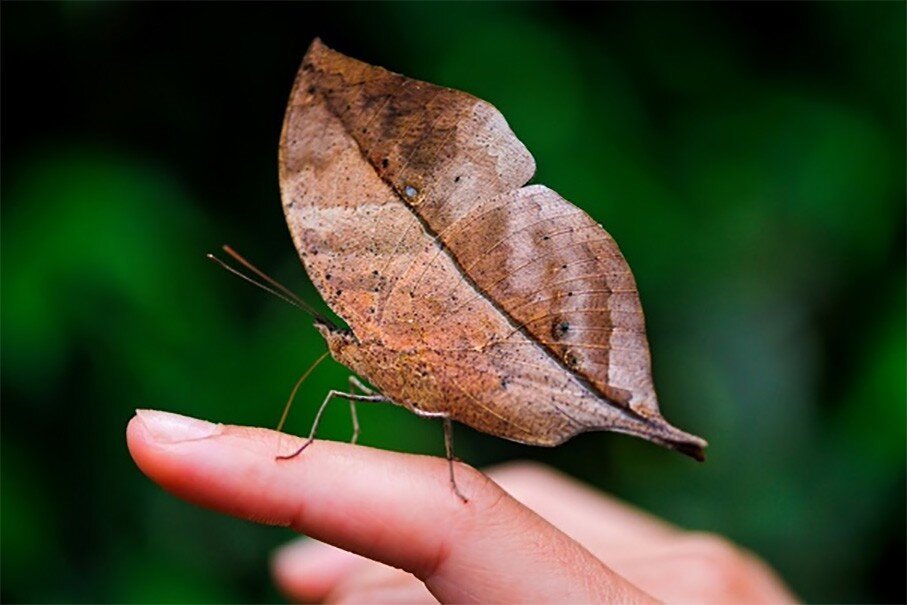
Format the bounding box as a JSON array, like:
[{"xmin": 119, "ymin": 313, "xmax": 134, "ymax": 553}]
[{"xmin": 127, "ymin": 410, "xmax": 793, "ymax": 603}]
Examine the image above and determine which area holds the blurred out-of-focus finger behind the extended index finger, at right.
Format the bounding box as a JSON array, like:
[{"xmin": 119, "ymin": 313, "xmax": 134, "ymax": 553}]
[{"xmin": 486, "ymin": 462, "xmax": 794, "ymax": 603}]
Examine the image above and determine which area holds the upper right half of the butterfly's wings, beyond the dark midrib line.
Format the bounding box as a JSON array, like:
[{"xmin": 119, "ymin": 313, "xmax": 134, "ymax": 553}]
[{"xmin": 302, "ymin": 42, "xmax": 658, "ymax": 413}]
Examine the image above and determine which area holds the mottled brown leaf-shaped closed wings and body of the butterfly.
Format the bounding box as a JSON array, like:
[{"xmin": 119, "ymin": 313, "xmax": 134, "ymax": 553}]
[{"xmin": 280, "ymin": 40, "xmax": 705, "ymax": 457}]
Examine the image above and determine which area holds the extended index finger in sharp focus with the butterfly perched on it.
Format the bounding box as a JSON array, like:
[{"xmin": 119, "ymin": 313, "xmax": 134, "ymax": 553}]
[{"xmin": 127, "ymin": 411, "xmax": 650, "ymax": 602}]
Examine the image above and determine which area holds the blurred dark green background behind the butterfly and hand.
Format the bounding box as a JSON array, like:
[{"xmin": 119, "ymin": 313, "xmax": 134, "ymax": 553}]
[{"xmin": 0, "ymin": 2, "xmax": 907, "ymax": 602}]
